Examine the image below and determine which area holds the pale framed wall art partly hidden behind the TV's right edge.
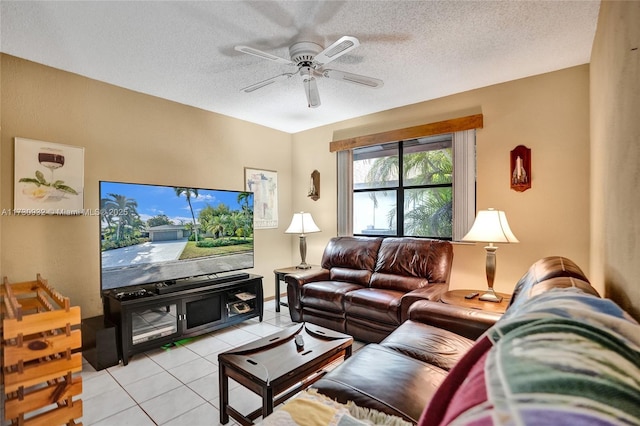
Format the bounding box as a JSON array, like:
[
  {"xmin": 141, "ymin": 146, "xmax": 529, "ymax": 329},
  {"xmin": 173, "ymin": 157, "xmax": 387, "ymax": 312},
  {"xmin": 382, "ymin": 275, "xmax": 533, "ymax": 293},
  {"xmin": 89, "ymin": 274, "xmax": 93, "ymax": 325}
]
[{"xmin": 244, "ymin": 167, "xmax": 278, "ymax": 229}]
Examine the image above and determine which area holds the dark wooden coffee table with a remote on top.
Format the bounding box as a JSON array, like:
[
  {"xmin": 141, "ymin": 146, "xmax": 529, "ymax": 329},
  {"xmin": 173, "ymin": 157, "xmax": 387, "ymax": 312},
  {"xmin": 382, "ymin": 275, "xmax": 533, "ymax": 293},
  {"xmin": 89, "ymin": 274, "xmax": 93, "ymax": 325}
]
[{"xmin": 218, "ymin": 323, "xmax": 353, "ymax": 425}]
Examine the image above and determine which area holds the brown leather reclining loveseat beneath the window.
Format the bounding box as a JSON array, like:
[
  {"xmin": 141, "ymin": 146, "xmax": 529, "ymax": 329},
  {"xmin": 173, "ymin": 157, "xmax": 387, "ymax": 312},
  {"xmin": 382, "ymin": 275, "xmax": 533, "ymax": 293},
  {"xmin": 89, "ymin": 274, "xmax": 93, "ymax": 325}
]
[{"xmin": 285, "ymin": 237, "xmax": 453, "ymax": 342}]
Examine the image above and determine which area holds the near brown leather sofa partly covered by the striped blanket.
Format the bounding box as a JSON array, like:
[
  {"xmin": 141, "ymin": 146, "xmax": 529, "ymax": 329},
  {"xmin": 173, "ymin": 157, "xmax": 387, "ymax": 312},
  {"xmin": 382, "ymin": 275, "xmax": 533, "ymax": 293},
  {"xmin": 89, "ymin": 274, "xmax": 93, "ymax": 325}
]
[{"xmin": 312, "ymin": 257, "xmax": 598, "ymax": 424}]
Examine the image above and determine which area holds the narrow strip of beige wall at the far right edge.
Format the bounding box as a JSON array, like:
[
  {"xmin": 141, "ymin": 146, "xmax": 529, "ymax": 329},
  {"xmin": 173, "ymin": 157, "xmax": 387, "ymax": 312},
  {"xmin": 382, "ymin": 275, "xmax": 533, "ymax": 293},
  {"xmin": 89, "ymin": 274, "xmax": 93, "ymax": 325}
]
[{"xmin": 590, "ymin": 1, "xmax": 640, "ymax": 319}]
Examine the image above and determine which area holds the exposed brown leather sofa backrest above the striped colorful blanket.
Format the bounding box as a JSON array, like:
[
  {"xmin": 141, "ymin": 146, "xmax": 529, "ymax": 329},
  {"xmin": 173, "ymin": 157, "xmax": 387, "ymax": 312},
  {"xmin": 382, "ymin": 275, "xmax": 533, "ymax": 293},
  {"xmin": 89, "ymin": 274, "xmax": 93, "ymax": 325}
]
[{"xmin": 510, "ymin": 256, "xmax": 600, "ymax": 310}]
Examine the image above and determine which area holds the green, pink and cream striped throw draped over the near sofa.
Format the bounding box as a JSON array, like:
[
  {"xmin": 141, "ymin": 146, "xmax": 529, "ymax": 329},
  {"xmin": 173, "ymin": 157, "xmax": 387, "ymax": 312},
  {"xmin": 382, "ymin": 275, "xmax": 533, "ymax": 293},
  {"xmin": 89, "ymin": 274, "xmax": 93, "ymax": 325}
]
[{"xmin": 450, "ymin": 289, "xmax": 640, "ymax": 426}]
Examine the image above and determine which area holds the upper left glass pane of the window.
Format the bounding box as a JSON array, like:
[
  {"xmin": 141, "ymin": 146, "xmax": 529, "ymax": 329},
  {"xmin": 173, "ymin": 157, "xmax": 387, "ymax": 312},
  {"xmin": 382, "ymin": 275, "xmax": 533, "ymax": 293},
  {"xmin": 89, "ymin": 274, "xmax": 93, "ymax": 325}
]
[{"xmin": 353, "ymin": 143, "xmax": 399, "ymax": 189}]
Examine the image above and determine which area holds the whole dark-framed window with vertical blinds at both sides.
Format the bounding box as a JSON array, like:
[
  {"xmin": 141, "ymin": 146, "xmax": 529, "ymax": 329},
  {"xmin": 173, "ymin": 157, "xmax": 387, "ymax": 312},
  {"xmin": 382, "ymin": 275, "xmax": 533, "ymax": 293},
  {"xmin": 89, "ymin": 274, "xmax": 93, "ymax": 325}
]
[{"xmin": 338, "ymin": 130, "xmax": 475, "ymax": 240}]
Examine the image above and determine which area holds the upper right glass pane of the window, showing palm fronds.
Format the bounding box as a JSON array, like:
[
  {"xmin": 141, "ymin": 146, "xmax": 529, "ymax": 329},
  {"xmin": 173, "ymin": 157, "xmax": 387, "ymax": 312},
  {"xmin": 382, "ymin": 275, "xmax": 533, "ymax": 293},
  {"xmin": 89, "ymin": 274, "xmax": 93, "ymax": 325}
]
[{"xmin": 402, "ymin": 135, "xmax": 453, "ymax": 186}]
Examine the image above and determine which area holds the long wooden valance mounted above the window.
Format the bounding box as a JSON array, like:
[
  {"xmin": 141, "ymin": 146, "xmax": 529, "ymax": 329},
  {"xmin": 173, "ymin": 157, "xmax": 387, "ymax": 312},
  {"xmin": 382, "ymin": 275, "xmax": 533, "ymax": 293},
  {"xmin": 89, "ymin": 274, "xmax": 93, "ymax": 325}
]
[{"xmin": 329, "ymin": 114, "xmax": 482, "ymax": 152}]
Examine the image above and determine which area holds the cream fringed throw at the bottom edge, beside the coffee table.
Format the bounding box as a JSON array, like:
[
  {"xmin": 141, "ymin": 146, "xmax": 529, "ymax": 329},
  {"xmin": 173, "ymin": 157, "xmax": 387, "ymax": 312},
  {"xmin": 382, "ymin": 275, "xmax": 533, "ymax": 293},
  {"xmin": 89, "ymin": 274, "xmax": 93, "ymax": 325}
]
[{"xmin": 261, "ymin": 389, "xmax": 411, "ymax": 426}]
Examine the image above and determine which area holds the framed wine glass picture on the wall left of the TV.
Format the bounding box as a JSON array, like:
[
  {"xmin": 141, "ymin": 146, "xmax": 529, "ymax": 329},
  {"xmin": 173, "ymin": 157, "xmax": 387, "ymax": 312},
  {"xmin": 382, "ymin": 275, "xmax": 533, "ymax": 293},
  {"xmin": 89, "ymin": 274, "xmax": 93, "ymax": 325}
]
[{"xmin": 13, "ymin": 138, "xmax": 84, "ymax": 215}]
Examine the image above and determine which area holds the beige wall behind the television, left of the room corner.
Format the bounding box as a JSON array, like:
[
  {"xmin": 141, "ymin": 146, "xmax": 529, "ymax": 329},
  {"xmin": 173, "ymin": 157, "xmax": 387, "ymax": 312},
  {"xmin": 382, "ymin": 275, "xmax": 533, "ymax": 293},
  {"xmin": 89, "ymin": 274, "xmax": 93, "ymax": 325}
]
[{"xmin": 0, "ymin": 55, "xmax": 293, "ymax": 317}]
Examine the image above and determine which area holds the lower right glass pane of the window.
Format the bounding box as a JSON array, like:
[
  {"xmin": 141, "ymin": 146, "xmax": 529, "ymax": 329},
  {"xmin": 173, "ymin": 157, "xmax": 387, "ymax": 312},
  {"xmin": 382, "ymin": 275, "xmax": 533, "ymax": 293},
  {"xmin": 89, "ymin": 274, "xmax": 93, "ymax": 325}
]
[{"xmin": 404, "ymin": 187, "xmax": 453, "ymax": 238}]
